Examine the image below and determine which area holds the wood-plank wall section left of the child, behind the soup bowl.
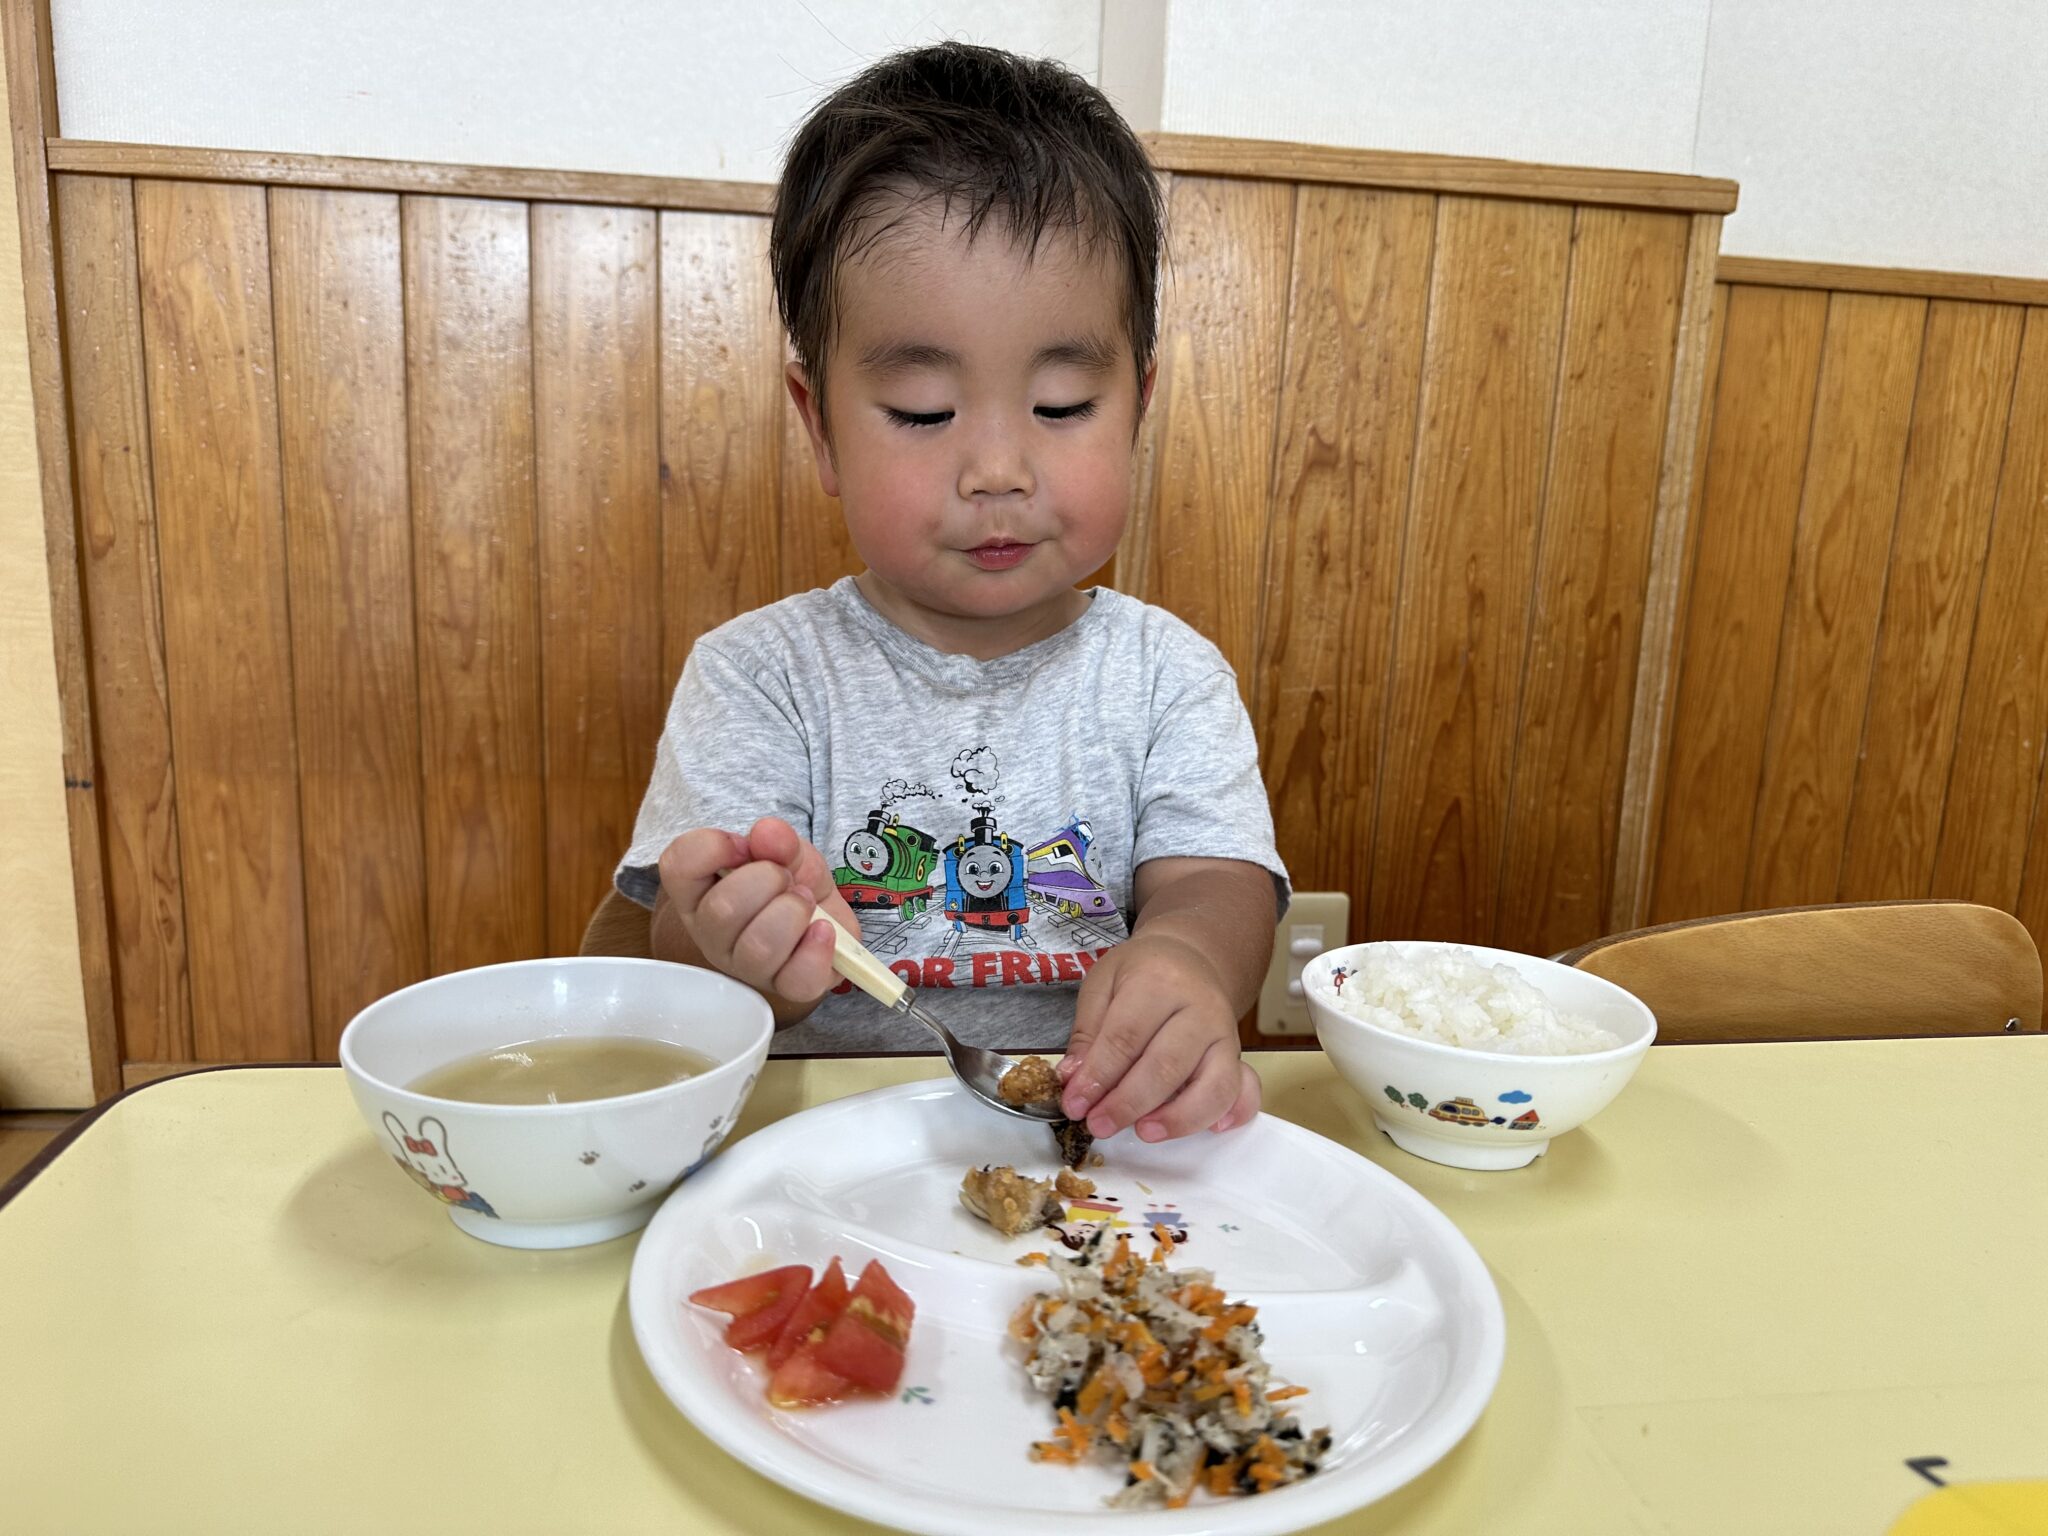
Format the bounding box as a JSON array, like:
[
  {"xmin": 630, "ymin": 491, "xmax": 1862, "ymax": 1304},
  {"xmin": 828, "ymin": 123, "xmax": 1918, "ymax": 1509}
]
[{"xmin": 55, "ymin": 174, "xmax": 852, "ymax": 1061}]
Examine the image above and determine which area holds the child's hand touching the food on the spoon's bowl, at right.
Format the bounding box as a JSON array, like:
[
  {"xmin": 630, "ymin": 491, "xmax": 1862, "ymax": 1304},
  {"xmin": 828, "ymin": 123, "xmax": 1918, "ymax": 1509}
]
[{"xmin": 1059, "ymin": 932, "xmax": 1260, "ymax": 1141}]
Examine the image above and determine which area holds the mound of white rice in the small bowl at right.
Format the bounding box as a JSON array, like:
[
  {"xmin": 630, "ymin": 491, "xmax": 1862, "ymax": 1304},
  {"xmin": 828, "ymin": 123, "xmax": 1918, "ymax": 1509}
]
[{"xmin": 1319, "ymin": 948, "xmax": 1622, "ymax": 1057}]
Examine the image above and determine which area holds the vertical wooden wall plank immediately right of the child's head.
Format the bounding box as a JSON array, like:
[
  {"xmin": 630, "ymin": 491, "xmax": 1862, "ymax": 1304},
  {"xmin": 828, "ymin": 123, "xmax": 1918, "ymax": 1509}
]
[{"xmin": 1118, "ymin": 176, "xmax": 1294, "ymax": 692}]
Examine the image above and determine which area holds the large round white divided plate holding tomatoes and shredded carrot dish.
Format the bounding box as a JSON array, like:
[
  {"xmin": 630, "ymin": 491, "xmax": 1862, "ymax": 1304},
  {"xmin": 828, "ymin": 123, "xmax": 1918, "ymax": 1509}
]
[{"xmin": 629, "ymin": 1081, "xmax": 1505, "ymax": 1536}]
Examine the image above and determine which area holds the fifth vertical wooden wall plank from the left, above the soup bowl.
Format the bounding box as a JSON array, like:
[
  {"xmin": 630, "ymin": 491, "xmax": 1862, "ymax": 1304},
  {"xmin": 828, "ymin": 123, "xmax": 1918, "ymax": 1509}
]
[{"xmin": 532, "ymin": 205, "xmax": 664, "ymax": 954}]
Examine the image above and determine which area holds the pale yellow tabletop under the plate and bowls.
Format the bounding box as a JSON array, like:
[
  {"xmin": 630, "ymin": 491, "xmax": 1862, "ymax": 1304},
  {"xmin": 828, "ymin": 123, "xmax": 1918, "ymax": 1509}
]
[{"xmin": 0, "ymin": 1036, "xmax": 2048, "ymax": 1536}]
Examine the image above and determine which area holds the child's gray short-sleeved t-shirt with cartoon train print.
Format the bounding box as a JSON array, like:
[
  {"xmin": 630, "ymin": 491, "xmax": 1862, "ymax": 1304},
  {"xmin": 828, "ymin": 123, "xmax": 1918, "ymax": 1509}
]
[{"xmin": 616, "ymin": 578, "xmax": 1286, "ymax": 1053}]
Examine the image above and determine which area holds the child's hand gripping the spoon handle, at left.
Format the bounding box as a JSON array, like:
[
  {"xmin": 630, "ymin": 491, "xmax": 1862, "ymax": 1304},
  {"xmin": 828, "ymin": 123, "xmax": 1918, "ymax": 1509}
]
[{"xmin": 662, "ymin": 817, "xmax": 860, "ymax": 1004}]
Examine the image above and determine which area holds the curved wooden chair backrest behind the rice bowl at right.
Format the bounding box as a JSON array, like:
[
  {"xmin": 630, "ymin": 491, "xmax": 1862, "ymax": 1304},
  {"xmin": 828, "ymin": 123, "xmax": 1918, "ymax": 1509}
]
[{"xmin": 1556, "ymin": 901, "xmax": 2042, "ymax": 1040}]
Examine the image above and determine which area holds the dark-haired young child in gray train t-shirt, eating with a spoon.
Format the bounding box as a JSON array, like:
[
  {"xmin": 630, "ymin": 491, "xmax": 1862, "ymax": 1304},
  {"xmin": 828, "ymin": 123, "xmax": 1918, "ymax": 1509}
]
[{"xmin": 616, "ymin": 43, "xmax": 1286, "ymax": 1141}]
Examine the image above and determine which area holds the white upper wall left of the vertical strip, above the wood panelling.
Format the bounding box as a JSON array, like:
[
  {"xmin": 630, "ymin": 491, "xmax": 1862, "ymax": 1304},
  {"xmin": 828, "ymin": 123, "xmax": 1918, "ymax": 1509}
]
[{"xmin": 51, "ymin": 0, "xmax": 1102, "ymax": 180}]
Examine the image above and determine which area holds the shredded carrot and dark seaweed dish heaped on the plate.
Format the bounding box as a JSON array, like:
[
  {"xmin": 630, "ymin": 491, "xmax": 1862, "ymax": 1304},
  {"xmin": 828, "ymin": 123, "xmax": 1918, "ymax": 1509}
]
[{"xmin": 1010, "ymin": 1227, "xmax": 1329, "ymax": 1509}]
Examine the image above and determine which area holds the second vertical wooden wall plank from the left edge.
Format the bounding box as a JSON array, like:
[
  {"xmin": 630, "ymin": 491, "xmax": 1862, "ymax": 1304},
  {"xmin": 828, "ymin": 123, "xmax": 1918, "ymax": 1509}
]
[{"xmin": 135, "ymin": 180, "xmax": 313, "ymax": 1061}]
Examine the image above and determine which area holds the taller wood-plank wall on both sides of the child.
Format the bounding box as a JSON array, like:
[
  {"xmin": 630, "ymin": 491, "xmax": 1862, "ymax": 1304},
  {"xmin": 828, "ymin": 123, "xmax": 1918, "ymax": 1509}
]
[{"xmin": 36, "ymin": 143, "xmax": 1744, "ymax": 1063}]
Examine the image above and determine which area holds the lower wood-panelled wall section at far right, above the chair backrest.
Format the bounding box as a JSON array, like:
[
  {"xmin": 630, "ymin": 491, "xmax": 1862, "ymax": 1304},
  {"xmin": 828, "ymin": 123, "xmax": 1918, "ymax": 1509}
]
[{"xmin": 1651, "ymin": 262, "xmax": 2048, "ymax": 946}]
